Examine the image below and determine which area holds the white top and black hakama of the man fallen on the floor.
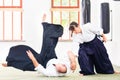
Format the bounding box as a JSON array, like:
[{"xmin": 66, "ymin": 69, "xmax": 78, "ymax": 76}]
[{"xmin": 6, "ymin": 22, "xmax": 70, "ymax": 76}]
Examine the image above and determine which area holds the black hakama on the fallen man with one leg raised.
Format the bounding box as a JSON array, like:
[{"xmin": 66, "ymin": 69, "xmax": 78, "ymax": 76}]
[{"xmin": 6, "ymin": 22, "xmax": 63, "ymax": 71}]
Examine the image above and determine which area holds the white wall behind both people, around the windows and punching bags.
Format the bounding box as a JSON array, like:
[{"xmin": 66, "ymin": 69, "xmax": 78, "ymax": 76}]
[{"xmin": 0, "ymin": 0, "xmax": 120, "ymax": 66}]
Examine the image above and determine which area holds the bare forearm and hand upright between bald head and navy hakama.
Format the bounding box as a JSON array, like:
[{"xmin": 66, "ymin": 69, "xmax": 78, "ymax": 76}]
[{"xmin": 68, "ymin": 51, "xmax": 76, "ymax": 71}]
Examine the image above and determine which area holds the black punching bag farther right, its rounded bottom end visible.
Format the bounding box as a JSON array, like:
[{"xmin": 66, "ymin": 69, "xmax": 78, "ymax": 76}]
[{"xmin": 101, "ymin": 3, "xmax": 110, "ymax": 34}]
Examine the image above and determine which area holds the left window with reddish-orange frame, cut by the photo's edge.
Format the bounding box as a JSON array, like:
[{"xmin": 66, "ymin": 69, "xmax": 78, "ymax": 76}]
[{"xmin": 0, "ymin": 0, "xmax": 22, "ymax": 41}]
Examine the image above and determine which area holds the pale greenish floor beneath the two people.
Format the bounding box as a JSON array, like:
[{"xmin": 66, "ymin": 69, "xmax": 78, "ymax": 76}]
[{"xmin": 0, "ymin": 65, "xmax": 120, "ymax": 80}]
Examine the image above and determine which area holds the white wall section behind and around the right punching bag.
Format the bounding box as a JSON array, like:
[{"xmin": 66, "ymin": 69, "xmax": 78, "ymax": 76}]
[{"xmin": 91, "ymin": 0, "xmax": 120, "ymax": 66}]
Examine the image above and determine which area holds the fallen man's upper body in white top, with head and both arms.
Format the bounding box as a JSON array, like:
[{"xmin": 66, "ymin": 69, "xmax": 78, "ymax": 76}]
[{"xmin": 26, "ymin": 50, "xmax": 76, "ymax": 76}]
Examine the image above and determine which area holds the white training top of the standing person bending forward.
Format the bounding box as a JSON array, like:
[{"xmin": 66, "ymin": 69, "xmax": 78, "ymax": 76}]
[{"xmin": 72, "ymin": 23, "xmax": 103, "ymax": 56}]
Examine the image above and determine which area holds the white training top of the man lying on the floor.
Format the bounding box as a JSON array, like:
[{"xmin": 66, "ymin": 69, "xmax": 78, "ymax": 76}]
[{"xmin": 35, "ymin": 58, "xmax": 71, "ymax": 76}]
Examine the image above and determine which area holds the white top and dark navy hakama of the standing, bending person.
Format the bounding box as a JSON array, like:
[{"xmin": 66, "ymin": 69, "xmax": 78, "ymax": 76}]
[{"xmin": 73, "ymin": 23, "xmax": 114, "ymax": 75}]
